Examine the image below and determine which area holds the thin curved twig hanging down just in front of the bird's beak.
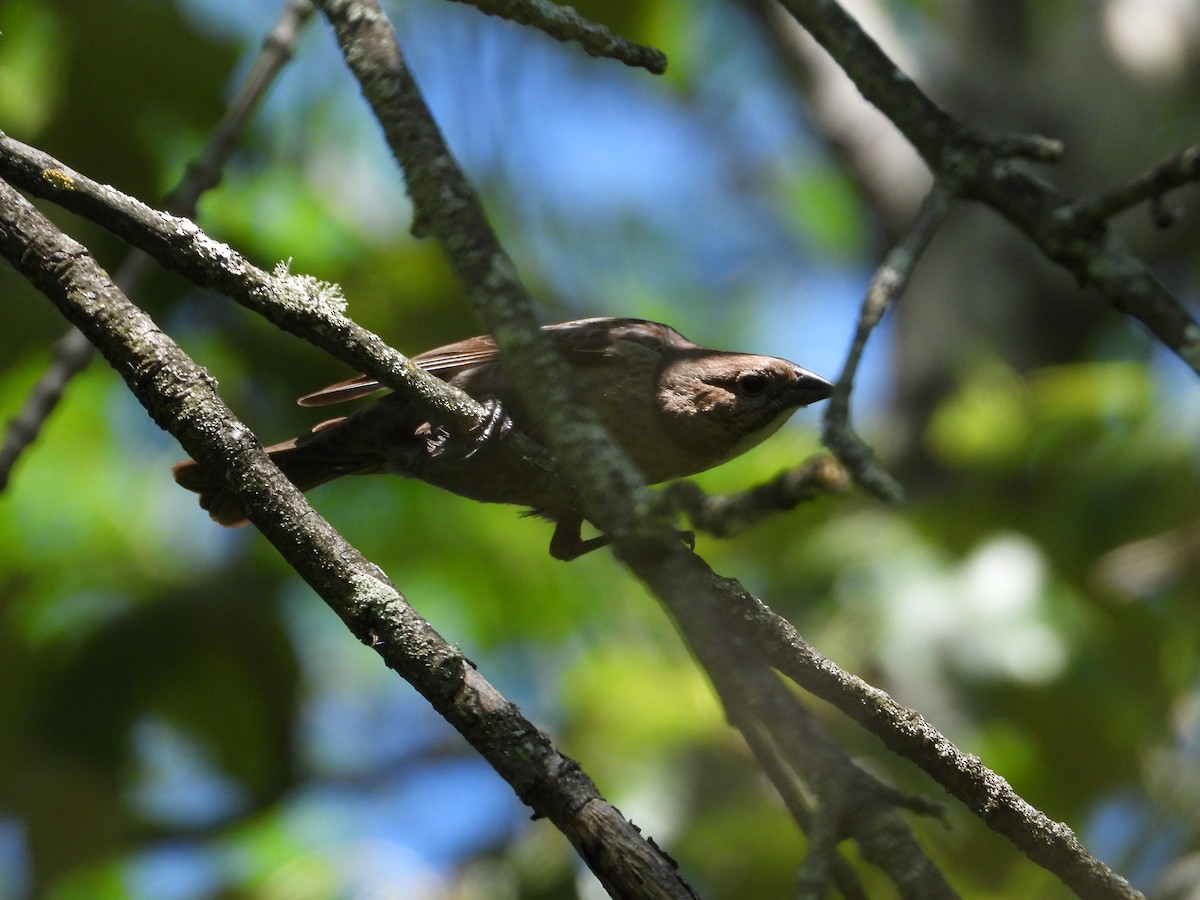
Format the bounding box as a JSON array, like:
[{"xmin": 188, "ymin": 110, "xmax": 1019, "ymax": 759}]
[{"xmin": 823, "ymin": 185, "xmax": 954, "ymax": 504}]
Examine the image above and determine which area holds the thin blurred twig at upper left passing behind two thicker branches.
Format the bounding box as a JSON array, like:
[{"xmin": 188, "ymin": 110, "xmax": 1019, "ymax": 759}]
[{"xmin": 0, "ymin": 0, "xmax": 313, "ymax": 491}]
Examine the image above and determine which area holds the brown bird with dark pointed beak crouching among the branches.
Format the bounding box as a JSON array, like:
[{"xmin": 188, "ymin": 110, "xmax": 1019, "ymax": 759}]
[{"xmin": 173, "ymin": 318, "xmax": 833, "ymax": 559}]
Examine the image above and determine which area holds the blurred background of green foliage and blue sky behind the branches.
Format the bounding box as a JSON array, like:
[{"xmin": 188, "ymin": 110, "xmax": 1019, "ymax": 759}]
[{"xmin": 0, "ymin": 0, "xmax": 1200, "ymax": 900}]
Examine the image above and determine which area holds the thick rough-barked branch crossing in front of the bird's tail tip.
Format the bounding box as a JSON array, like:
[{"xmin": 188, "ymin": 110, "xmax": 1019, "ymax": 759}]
[{"xmin": 0, "ymin": 181, "xmax": 695, "ymax": 899}]
